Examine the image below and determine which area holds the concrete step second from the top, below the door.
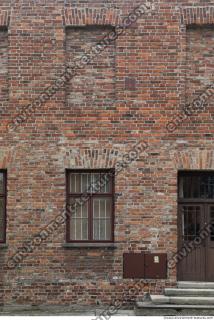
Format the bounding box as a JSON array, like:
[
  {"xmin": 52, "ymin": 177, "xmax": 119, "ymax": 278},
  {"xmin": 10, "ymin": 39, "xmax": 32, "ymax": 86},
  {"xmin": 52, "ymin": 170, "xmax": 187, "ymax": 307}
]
[{"xmin": 164, "ymin": 288, "xmax": 214, "ymax": 297}]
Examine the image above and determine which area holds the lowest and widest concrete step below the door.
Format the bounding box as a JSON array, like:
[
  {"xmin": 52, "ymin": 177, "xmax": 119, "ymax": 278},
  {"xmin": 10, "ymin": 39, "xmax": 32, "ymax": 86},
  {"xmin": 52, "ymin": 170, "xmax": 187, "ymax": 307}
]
[{"xmin": 134, "ymin": 302, "xmax": 214, "ymax": 316}]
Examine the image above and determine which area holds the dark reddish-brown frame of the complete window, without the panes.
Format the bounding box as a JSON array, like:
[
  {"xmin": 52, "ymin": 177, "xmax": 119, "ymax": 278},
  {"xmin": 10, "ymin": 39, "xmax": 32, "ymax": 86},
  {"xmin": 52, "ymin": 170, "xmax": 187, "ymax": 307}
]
[{"xmin": 66, "ymin": 169, "xmax": 115, "ymax": 243}]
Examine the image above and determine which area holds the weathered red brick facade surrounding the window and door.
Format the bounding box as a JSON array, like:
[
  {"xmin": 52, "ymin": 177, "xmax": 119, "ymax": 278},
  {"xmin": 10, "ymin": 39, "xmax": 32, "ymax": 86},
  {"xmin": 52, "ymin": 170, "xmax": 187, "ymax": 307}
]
[{"xmin": 0, "ymin": 0, "xmax": 214, "ymax": 305}]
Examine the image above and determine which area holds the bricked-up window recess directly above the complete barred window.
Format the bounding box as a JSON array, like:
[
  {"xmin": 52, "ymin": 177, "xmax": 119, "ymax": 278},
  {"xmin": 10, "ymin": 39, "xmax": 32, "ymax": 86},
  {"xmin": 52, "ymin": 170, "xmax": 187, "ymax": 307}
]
[{"xmin": 66, "ymin": 26, "xmax": 115, "ymax": 120}]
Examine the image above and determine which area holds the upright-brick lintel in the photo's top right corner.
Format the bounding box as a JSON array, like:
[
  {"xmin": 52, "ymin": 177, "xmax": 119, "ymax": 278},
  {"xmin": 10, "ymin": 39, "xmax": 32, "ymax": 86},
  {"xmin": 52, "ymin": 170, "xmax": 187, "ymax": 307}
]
[{"xmin": 181, "ymin": 6, "xmax": 214, "ymax": 25}]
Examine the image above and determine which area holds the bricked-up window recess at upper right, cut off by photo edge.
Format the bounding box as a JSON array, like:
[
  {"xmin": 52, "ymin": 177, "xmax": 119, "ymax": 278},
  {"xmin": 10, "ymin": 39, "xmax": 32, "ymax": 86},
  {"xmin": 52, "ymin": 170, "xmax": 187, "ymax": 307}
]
[{"xmin": 186, "ymin": 25, "xmax": 214, "ymax": 126}]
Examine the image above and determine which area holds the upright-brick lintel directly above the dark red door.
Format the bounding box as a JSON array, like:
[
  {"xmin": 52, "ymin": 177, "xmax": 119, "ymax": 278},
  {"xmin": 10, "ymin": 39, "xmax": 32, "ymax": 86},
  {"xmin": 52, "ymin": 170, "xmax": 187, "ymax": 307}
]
[{"xmin": 173, "ymin": 149, "xmax": 214, "ymax": 170}]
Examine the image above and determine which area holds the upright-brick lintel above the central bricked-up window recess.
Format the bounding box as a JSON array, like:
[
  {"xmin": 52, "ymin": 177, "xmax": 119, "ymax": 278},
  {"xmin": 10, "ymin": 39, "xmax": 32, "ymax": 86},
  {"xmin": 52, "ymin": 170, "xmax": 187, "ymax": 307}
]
[{"xmin": 64, "ymin": 8, "xmax": 120, "ymax": 26}]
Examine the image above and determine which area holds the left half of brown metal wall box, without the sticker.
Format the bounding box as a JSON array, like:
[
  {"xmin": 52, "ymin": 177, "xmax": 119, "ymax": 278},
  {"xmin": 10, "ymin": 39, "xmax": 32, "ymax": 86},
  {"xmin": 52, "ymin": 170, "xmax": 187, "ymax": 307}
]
[{"xmin": 123, "ymin": 253, "xmax": 145, "ymax": 279}]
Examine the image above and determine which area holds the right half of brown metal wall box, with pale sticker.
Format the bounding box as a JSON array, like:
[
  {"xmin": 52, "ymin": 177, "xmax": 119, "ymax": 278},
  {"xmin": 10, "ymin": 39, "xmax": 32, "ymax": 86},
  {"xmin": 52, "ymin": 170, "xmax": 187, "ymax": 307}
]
[{"xmin": 145, "ymin": 253, "xmax": 167, "ymax": 279}]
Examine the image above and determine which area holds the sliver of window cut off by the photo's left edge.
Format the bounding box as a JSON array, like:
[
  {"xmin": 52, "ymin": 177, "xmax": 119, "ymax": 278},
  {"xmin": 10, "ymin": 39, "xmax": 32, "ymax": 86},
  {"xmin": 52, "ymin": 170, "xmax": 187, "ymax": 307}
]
[{"xmin": 0, "ymin": 170, "xmax": 7, "ymax": 243}]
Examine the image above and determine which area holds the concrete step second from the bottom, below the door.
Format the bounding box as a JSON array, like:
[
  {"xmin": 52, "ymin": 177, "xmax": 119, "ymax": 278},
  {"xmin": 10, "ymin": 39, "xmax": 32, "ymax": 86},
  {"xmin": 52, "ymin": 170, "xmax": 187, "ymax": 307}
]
[{"xmin": 151, "ymin": 295, "xmax": 214, "ymax": 305}]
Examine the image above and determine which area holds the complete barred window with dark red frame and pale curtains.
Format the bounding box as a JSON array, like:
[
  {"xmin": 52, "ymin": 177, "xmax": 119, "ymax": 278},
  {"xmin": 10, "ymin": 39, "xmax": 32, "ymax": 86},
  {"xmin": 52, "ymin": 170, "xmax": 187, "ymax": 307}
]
[{"xmin": 67, "ymin": 170, "xmax": 114, "ymax": 242}]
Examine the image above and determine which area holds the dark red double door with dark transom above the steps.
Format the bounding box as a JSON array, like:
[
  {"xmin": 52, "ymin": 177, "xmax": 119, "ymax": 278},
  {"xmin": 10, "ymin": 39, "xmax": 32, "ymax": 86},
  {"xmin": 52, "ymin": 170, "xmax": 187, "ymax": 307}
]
[{"xmin": 177, "ymin": 172, "xmax": 214, "ymax": 281}]
